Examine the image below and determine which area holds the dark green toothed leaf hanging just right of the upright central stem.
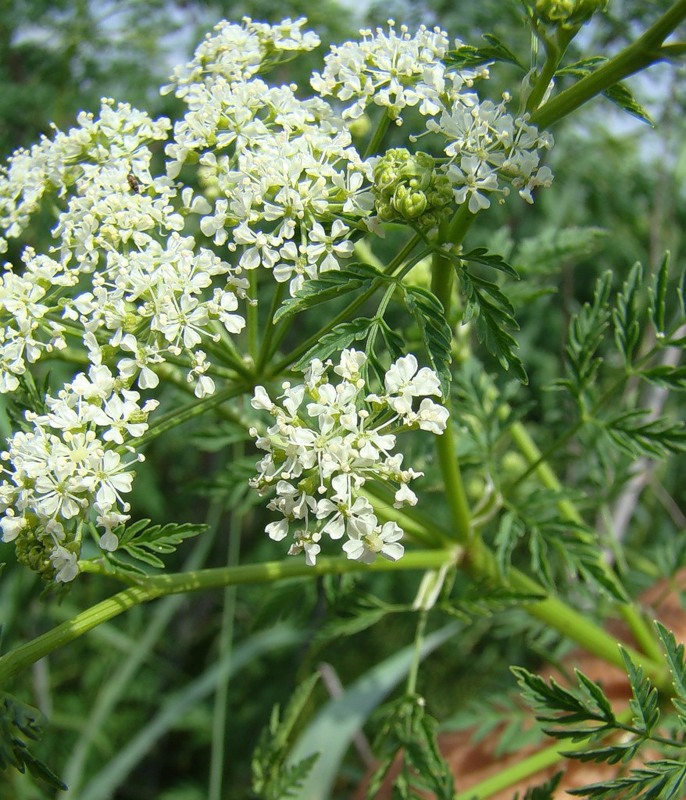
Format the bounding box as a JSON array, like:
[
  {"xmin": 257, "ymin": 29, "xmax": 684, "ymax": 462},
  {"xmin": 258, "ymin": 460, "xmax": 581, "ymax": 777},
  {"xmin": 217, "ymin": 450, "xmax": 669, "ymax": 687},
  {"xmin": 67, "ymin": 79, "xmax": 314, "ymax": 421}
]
[{"xmin": 455, "ymin": 265, "xmax": 528, "ymax": 383}]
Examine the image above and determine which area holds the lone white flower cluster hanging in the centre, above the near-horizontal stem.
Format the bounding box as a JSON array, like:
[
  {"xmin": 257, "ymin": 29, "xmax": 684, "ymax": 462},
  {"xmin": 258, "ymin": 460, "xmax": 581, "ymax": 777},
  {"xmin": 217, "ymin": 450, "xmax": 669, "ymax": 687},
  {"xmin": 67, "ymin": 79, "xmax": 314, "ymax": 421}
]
[{"xmin": 251, "ymin": 350, "xmax": 448, "ymax": 565}]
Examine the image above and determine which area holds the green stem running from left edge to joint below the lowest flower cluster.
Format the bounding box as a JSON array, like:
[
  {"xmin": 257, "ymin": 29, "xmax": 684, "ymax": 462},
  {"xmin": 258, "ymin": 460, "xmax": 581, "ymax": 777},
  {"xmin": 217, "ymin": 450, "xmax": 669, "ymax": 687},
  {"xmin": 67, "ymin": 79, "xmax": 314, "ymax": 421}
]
[{"xmin": 0, "ymin": 549, "xmax": 455, "ymax": 686}]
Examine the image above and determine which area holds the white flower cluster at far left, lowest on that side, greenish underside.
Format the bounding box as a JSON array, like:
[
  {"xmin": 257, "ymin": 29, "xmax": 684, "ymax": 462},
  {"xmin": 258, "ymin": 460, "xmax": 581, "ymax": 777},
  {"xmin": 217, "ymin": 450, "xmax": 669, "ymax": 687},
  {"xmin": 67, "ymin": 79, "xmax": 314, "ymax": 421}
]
[{"xmin": 0, "ymin": 366, "xmax": 157, "ymax": 582}]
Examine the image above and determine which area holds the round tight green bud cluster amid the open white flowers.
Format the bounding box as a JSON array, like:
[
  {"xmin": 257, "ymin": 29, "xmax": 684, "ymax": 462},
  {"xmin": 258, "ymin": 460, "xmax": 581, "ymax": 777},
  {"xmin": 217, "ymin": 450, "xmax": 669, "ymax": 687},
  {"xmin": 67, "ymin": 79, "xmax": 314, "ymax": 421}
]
[{"xmin": 373, "ymin": 148, "xmax": 453, "ymax": 230}]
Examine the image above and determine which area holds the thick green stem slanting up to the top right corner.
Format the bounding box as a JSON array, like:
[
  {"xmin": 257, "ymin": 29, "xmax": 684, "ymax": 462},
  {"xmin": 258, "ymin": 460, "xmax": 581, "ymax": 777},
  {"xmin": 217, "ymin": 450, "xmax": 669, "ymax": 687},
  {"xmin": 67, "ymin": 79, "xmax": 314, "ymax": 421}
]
[{"xmin": 531, "ymin": 0, "xmax": 686, "ymax": 128}]
